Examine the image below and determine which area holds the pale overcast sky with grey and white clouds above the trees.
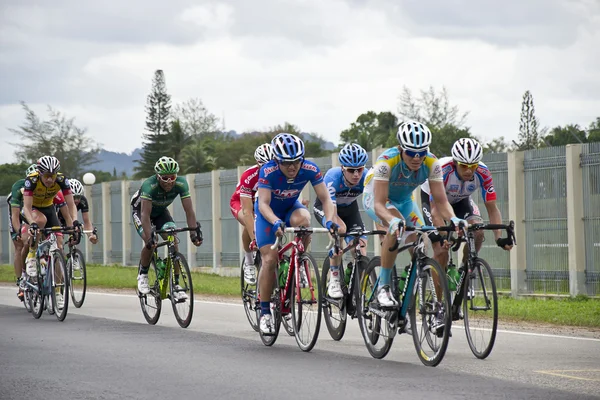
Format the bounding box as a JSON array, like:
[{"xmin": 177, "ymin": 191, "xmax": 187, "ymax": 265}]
[{"xmin": 0, "ymin": 0, "xmax": 600, "ymax": 162}]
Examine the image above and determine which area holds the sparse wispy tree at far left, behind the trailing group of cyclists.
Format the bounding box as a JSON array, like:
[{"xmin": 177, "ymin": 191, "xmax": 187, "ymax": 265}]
[{"xmin": 9, "ymin": 102, "xmax": 100, "ymax": 176}]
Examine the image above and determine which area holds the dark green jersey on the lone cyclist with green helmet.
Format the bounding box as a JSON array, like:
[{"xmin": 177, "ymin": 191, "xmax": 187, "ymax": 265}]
[{"xmin": 131, "ymin": 175, "xmax": 190, "ymax": 218}]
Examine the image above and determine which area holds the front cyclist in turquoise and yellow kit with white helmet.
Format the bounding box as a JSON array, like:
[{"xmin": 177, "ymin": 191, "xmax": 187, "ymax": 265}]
[{"xmin": 363, "ymin": 121, "xmax": 461, "ymax": 332}]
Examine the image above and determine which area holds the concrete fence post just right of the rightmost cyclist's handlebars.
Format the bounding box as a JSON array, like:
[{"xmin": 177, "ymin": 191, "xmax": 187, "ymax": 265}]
[{"xmin": 508, "ymin": 151, "xmax": 527, "ymax": 297}]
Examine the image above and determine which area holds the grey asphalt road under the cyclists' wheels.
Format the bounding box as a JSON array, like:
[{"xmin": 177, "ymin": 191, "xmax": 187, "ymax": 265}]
[{"xmin": 0, "ymin": 287, "xmax": 600, "ymax": 400}]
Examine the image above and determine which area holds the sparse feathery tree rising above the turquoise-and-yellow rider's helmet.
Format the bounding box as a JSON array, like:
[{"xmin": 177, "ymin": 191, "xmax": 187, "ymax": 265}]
[{"xmin": 398, "ymin": 86, "xmax": 469, "ymax": 129}]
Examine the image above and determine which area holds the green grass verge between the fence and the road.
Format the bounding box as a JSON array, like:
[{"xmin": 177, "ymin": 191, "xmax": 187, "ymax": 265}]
[{"xmin": 0, "ymin": 265, "xmax": 600, "ymax": 328}]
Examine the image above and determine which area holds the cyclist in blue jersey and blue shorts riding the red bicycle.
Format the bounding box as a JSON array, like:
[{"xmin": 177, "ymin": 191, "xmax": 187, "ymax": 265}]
[{"xmin": 254, "ymin": 133, "xmax": 337, "ymax": 335}]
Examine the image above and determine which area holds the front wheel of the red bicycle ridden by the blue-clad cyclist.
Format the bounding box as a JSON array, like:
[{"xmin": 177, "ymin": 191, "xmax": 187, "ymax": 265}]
[{"xmin": 291, "ymin": 253, "xmax": 322, "ymax": 351}]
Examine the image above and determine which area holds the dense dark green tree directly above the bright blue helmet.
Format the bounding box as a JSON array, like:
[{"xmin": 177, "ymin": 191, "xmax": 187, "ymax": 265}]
[{"xmin": 340, "ymin": 111, "xmax": 398, "ymax": 151}]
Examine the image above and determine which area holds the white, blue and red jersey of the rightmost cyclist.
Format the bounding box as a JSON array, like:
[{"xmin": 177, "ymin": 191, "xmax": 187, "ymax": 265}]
[{"xmin": 421, "ymin": 157, "xmax": 496, "ymax": 204}]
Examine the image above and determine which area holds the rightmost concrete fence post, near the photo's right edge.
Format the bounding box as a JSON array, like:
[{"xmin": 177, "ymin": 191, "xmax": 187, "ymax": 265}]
[{"xmin": 566, "ymin": 144, "xmax": 587, "ymax": 296}]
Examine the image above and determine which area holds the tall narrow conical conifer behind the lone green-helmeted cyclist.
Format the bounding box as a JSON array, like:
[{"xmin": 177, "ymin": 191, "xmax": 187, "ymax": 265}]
[{"xmin": 134, "ymin": 69, "xmax": 171, "ymax": 178}]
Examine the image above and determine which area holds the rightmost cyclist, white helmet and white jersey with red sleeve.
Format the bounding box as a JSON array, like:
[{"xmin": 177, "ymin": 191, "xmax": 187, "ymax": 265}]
[{"xmin": 421, "ymin": 138, "xmax": 513, "ymax": 268}]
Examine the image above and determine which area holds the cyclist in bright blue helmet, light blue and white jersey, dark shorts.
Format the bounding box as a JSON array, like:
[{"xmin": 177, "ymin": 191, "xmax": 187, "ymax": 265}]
[{"xmin": 313, "ymin": 143, "xmax": 369, "ymax": 299}]
